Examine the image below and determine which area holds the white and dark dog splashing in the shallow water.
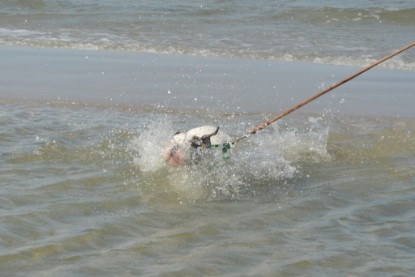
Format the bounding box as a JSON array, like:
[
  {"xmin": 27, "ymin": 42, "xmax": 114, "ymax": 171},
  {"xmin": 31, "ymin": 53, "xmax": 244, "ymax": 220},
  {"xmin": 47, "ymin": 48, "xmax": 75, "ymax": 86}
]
[{"xmin": 165, "ymin": 126, "xmax": 231, "ymax": 167}]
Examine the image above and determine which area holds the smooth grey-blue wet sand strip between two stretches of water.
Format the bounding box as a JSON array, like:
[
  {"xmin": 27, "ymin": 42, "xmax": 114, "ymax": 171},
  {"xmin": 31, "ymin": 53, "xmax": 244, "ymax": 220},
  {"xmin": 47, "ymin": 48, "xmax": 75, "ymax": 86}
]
[{"xmin": 0, "ymin": 46, "xmax": 415, "ymax": 117}]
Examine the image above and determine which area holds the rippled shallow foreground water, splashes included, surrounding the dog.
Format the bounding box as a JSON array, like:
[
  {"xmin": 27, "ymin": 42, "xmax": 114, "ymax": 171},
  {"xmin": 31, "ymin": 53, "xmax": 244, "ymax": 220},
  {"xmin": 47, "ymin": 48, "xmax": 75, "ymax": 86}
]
[{"xmin": 0, "ymin": 101, "xmax": 415, "ymax": 276}]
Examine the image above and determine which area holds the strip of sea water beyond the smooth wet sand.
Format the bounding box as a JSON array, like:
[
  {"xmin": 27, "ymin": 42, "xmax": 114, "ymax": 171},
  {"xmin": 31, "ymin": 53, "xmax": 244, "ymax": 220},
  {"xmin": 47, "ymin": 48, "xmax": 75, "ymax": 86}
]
[{"xmin": 0, "ymin": 0, "xmax": 415, "ymax": 69}]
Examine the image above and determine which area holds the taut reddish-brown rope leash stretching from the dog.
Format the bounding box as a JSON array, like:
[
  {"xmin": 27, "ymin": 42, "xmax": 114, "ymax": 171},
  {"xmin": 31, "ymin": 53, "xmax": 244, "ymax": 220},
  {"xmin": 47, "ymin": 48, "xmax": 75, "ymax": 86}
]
[{"xmin": 230, "ymin": 41, "xmax": 415, "ymax": 144}]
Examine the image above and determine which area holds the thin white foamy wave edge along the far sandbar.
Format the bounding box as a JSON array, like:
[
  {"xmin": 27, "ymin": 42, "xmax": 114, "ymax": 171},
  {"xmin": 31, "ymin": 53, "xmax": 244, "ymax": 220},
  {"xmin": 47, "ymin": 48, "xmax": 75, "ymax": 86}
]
[{"xmin": 0, "ymin": 28, "xmax": 415, "ymax": 70}]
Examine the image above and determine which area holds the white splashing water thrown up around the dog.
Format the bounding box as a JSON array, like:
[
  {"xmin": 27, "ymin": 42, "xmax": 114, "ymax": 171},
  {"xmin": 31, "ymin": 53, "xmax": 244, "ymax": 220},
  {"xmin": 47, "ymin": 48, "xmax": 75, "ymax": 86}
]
[{"xmin": 129, "ymin": 113, "xmax": 330, "ymax": 202}]
